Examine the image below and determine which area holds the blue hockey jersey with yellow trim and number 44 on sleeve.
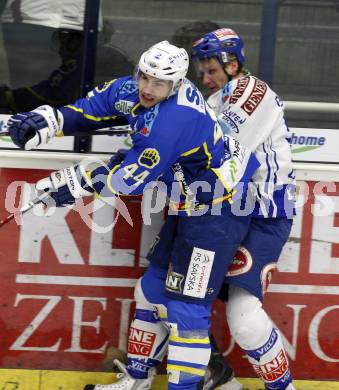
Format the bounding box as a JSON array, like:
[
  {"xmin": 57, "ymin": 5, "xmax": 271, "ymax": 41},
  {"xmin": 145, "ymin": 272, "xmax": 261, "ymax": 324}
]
[{"xmin": 60, "ymin": 77, "xmax": 259, "ymax": 213}]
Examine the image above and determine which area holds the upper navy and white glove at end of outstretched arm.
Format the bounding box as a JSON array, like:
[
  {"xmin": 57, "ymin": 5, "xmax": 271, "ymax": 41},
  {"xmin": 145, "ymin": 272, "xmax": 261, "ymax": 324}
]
[{"xmin": 8, "ymin": 105, "xmax": 63, "ymax": 150}]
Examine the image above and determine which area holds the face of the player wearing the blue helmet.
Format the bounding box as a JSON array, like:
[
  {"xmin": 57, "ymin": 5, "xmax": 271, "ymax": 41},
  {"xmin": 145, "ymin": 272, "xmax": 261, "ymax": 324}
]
[{"xmin": 199, "ymin": 58, "xmax": 228, "ymax": 93}]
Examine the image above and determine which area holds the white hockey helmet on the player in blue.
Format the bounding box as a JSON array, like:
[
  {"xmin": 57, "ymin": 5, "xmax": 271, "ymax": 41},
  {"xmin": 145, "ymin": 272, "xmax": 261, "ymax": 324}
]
[{"xmin": 138, "ymin": 41, "xmax": 189, "ymax": 95}]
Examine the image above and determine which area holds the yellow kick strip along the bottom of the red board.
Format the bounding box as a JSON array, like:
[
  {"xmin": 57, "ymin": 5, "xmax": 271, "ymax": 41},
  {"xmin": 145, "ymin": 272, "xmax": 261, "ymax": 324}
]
[{"xmin": 0, "ymin": 369, "xmax": 339, "ymax": 390}]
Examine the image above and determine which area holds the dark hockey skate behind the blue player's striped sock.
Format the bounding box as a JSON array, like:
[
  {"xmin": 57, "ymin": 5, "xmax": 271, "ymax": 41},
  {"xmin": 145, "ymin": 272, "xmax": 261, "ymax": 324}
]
[{"xmin": 198, "ymin": 353, "xmax": 243, "ymax": 390}]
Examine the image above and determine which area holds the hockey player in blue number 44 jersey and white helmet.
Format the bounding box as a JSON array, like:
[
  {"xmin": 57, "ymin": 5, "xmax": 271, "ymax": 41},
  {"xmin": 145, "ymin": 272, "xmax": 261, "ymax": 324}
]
[{"xmin": 9, "ymin": 41, "xmax": 259, "ymax": 390}]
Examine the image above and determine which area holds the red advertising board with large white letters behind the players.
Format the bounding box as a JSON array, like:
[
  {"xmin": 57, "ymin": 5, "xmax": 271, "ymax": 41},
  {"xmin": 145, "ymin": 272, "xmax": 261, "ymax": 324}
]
[{"xmin": 0, "ymin": 168, "xmax": 339, "ymax": 380}]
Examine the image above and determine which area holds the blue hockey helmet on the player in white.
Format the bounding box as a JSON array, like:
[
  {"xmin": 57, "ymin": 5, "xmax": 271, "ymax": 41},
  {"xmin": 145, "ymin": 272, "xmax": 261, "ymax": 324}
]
[{"xmin": 192, "ymin": 28, "xmax": 245, "ymax": 65}]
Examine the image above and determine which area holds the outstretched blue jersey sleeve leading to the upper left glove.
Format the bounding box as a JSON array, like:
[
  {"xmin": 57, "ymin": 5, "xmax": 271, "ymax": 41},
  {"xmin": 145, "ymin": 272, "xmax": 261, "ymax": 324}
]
[{"xmin": 59, "ymin": 78, "xmax": 127, "ymax": 135}]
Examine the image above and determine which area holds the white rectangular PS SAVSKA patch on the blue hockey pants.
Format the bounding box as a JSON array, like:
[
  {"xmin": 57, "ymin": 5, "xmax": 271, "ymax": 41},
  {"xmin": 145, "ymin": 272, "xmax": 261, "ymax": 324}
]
[{"xmin": 183, "ymin": 247, "xmax": 215, "ymax": 298}]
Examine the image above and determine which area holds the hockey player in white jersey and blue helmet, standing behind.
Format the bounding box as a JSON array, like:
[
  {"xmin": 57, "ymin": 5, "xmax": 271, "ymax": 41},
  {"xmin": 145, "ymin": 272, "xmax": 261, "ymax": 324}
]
[{"xmin": 192, "ymin": 28, "xmax": 295, "ymax": 390}]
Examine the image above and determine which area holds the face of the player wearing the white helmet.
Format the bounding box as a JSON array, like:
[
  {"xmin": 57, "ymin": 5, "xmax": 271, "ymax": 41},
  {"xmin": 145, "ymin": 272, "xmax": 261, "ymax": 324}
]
[{"xmin": 138, "ymin": 72, "xmax": 171, "ymax": 108}]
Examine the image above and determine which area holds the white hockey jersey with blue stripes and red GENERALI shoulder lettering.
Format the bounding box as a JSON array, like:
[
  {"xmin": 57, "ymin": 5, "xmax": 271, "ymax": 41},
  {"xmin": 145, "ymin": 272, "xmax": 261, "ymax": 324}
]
[{"xmin": 208, "ymin": 75, "xmax": 295, "ymax": 218}]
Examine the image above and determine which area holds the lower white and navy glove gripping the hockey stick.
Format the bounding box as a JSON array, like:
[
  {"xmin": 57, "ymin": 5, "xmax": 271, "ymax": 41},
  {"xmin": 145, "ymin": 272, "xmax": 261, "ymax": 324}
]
[{"xmin": 35, "ymin": 165, "xmax": 94, "ymax": 207}]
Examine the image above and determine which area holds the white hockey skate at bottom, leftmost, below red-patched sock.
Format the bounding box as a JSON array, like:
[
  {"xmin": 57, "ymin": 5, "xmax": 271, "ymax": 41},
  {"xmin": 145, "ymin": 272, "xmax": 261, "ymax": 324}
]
[{"xmin": 84, "ymin": 359, "xmax": 155, "ymax": 390}]
